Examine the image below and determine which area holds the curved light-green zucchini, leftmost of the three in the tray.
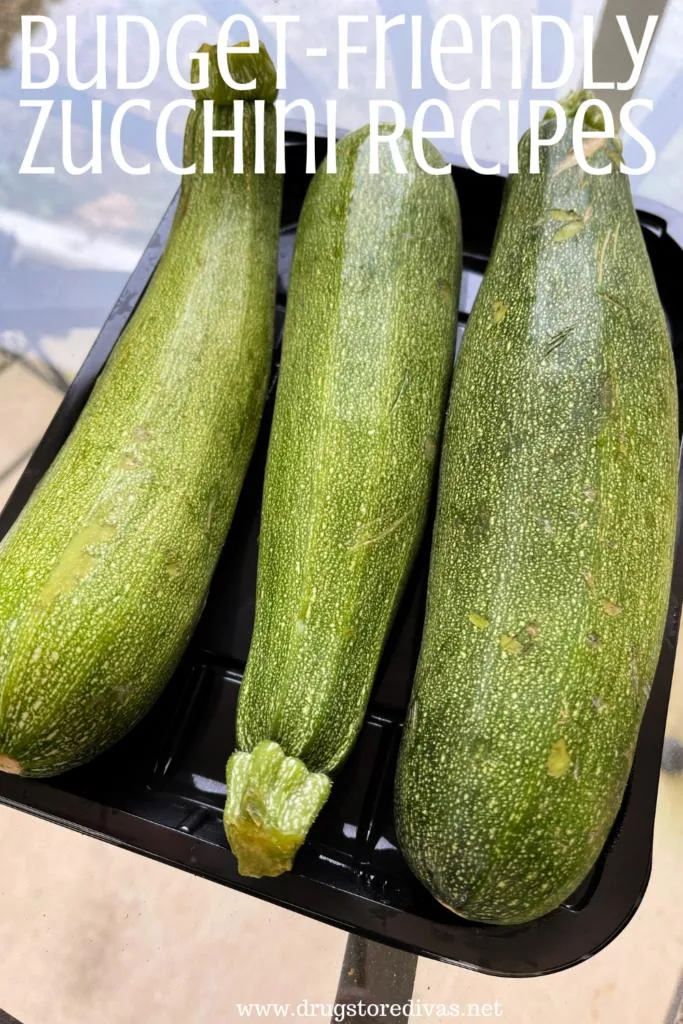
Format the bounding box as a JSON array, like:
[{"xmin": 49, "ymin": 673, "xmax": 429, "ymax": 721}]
[{"xmin": 0, "ymin": 39, "xmax": 282, "ymax": 775}]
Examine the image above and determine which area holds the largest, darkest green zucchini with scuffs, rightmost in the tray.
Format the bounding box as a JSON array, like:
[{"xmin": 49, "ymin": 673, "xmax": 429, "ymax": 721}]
[{"xmin": 395, "ymin": 93, "xmax": 678, "ymax": 925}]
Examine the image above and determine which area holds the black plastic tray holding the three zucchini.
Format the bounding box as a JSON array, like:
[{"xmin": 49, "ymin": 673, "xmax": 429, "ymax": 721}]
[{"xmin": 0, "ymin": 139, "xmax": 683, "ymax": 977}]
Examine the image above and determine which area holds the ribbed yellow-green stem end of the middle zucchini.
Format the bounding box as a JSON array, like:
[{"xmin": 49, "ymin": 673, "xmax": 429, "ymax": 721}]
[{"xmin": 223, "ymin": 739, "xmax": 332, "ymax": 879}]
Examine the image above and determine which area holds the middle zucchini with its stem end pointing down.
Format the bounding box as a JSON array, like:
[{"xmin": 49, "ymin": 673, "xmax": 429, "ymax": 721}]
[{"xmin": 224, "ymin": 128, "xmax": 461, "ymax": 877}]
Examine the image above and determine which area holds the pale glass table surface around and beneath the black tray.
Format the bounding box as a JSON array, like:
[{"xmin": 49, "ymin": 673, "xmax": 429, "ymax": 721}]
[{"xmin": 0, "ymin": 0, "xmax": 683, "ymax": 1024}]
